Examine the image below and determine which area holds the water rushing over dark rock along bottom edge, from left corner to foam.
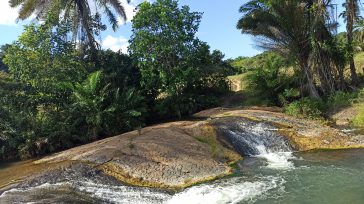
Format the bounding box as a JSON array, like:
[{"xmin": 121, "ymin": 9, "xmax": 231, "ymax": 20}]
[{"xmin": 0, "ymin": 176, "xmax": 285, "ymax": 204}]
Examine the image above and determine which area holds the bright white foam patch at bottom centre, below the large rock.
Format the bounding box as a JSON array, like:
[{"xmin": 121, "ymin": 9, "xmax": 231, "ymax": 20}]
[{"xmin": 168, "ymin": 177, "xmax": 284, "ymax": 204}]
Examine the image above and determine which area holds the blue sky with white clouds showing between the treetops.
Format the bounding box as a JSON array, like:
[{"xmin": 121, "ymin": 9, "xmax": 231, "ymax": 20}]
[{"xmin": 0, "ymin": 0, "xmax": 350, "ymax": 58}]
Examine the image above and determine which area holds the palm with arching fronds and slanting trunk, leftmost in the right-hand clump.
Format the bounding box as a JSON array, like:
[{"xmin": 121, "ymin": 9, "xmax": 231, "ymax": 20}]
[{"xmin": 237, "ymin": 0, "xmax": 319, "ymax": 98}]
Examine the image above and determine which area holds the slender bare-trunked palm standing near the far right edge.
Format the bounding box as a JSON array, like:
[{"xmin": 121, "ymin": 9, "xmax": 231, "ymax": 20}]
[{"xmin": 343, "ymin": 0, "xmax": 360, "ymax": 86}]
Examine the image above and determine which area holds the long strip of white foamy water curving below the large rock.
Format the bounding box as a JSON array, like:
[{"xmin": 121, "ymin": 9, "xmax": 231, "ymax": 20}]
[{"xmin": 2, "ymin": 176, "xmax": 285, "ymax": 204}]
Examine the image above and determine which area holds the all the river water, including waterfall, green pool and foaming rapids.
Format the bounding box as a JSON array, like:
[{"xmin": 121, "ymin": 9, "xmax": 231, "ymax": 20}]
[{"xmin": 0, "ymin": 122, "xmax": 364, "ymax": 204}]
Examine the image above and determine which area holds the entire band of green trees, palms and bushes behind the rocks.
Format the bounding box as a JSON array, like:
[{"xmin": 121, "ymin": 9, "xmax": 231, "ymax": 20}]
[{"xmin": 0, "ymin": 0, "xmax": 364, "ymax": 160}]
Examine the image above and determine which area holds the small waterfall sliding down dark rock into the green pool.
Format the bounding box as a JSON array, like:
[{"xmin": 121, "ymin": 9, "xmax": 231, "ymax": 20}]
[{"xmin": 218, "ymin": 119, "xmax": 294, "ymax": 169}]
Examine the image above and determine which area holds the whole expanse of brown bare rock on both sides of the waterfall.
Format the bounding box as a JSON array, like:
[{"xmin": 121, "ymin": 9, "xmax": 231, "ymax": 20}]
[{"xmin": 0, "ymin": 108, "xmax": 364, "ymax": 189}]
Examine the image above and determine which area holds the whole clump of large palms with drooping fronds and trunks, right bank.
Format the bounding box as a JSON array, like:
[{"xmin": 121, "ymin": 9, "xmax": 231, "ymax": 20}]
[{"xmin": 237, "ymin": 0, "xmax": 336, "ymax": 98}]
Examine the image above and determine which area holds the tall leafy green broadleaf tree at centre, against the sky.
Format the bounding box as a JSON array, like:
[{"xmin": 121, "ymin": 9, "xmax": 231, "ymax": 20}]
[{"xmin": 130, "ymin": 0, "xmax": 202, "ymax": 116}]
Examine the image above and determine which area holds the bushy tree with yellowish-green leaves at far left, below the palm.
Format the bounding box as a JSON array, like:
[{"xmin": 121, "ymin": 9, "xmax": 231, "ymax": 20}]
[{"xmin": 4, "ymin": 24, "xmax": 86, "ymax": 105}]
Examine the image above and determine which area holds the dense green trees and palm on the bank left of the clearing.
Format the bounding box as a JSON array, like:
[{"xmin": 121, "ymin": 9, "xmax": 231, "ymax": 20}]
[{"xmin": 0, "ymin": 0, "xmax": 231, "ymax": 160}]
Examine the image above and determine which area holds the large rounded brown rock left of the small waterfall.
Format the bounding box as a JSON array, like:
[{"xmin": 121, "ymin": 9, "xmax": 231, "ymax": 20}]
[{"xmin": 36, "ymin": 121, "xmax": 240, "ymax": 188}]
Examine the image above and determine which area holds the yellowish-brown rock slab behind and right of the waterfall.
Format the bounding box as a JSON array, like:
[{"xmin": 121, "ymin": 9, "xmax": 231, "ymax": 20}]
[{"xmin": 210, "ymin": 109, "xmax": 364, "ymax": 151}]
